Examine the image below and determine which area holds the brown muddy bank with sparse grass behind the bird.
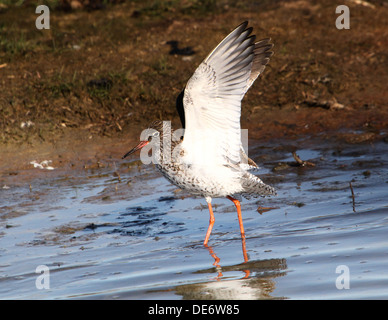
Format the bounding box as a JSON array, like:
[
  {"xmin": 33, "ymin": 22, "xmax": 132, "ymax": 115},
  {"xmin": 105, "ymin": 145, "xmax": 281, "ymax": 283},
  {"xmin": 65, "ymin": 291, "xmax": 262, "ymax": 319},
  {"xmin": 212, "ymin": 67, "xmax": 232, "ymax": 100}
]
[{"xmin": 0, "ymin": 1, "xmax": 388, "ymax": 169}]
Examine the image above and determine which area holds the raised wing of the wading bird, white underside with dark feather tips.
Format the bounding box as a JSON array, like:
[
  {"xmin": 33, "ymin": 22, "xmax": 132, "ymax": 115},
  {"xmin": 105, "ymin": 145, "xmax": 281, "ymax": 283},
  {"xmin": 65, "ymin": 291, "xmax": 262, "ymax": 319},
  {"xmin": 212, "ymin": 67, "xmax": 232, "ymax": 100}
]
[{"xmin": 182, "ymin": 22, "xmax": 272, "ymax": 168}]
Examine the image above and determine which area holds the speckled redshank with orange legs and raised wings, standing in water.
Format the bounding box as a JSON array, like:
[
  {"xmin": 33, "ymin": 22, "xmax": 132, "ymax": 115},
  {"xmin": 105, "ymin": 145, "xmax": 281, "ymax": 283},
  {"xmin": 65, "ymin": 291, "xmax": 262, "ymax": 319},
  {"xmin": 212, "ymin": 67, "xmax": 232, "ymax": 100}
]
[{"xmin": 123, "ymin": 22, "xmax": 276, "ymax": 245}]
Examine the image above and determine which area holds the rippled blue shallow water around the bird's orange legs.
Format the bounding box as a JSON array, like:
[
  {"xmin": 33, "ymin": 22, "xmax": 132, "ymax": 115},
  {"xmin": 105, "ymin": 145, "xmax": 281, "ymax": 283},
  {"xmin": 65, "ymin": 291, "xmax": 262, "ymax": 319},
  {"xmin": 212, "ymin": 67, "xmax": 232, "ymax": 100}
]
[{"xmin": 0, "ymin": 141, "xmax": 388, "ymax": 299}]
